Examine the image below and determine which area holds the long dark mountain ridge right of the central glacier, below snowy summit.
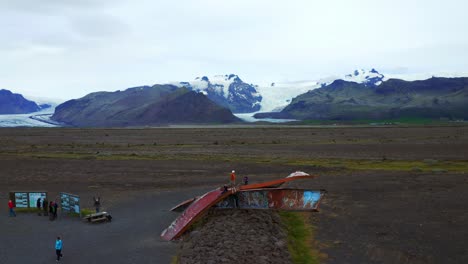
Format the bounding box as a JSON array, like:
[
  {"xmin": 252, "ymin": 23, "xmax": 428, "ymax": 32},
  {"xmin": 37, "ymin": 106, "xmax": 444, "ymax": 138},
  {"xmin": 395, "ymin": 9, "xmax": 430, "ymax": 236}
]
[{"xmin": 256, "ymin": 77, "xmax": 468, "ymax": 120}]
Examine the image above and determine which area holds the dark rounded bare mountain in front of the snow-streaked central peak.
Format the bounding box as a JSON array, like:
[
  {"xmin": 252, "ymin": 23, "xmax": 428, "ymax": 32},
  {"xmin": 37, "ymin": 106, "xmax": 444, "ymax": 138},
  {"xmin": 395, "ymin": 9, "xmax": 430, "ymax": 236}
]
[{"xmin": 52, "ymin": 85, "xmax": 240, "ymax": 127}]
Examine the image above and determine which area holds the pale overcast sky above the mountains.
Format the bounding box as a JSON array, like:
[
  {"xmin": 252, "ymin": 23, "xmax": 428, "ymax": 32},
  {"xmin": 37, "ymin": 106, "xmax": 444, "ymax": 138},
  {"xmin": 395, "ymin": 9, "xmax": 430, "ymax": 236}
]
[{"xmin": 0, "ymin": 0, "xmax": 468, "ymax": 99}]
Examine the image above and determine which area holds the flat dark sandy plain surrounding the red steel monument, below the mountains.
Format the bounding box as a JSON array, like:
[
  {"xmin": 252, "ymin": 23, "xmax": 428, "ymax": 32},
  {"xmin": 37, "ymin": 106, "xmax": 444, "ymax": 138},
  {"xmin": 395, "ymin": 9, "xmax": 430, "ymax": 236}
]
[{"xmin": 0, "ymin": 126, "xmax": 468, "ymax": 263}]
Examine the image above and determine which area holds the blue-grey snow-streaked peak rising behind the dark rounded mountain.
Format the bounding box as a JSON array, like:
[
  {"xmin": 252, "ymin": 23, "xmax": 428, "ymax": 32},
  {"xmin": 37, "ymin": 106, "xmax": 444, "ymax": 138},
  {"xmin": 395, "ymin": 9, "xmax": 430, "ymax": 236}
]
[{"xmin": 171, "ymin": 74, "xmax": 262, "ymax": 113}]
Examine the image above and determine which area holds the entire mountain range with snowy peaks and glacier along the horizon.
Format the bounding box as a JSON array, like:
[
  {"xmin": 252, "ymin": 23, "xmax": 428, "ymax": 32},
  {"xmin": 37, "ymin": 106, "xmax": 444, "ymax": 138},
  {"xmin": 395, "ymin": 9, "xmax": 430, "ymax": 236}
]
[{"xmin": 0, "ymin": 69, "xmax": 468, "ymax": 127}]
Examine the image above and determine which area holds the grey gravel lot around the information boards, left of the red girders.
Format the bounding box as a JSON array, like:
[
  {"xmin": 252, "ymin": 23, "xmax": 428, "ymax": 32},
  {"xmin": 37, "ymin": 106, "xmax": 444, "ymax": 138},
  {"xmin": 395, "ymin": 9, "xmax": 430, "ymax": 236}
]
[{"xmin": 0, "ymin": 190, "xmax": 205, "ymax": 264}]
